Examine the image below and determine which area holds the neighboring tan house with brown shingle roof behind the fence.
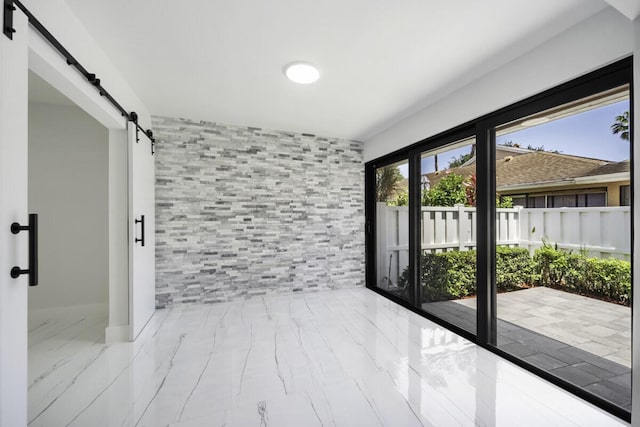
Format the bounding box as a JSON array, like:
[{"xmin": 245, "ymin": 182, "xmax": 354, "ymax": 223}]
[{"xmin": 425, "ymin": 146, "xmax": 630, "ymax": 208}]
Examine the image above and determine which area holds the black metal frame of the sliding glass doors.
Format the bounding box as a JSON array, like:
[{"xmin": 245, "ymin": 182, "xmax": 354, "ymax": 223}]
[{"xmin": 365, "ymin": 56, "xmax": 635, "ymax": 422}]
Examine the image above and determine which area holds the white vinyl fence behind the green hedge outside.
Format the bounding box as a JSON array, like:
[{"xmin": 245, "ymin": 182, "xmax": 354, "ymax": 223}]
[{"xmin": 376, "ymin": 203, "xmax": 631, "ymax": 284}]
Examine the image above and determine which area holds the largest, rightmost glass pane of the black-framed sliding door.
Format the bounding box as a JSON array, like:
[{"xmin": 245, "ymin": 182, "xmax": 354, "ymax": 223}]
[{"xmin": 494, "ymin": 85, "xmax": 631, "ymax": 410}]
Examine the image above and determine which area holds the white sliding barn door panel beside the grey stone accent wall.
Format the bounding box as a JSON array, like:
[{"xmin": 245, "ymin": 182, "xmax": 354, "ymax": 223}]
[{"xmin": 128, "ymin": 123, "xmax": 156, "ymax": 340}]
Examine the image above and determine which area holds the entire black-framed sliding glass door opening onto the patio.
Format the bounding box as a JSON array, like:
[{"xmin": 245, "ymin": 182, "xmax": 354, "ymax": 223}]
[{"xmin": 366, "ymin": 59, "xmax": 634, "ymax": 420}]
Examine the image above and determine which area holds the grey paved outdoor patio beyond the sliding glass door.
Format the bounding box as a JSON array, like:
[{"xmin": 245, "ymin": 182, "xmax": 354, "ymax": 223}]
[{"xmin": 422, "ymin": 287, "xmax": 631, "ymax": 410}]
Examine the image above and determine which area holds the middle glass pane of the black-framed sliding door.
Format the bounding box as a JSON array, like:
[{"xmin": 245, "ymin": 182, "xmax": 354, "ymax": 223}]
[{"xmin": 419, "ymin": 138, "xmax": 477, "ymax": 334}]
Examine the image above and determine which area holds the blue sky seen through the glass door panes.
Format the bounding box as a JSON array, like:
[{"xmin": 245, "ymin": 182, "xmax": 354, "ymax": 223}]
[{"xmin": 399, "ymin": 101, "xmax": 629, "ymax": 177}]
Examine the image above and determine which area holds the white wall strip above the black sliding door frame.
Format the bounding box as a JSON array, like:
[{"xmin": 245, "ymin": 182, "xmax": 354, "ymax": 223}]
[{"xmin": 364, "ymin": 8, "xmax": 634, "ymax": 161}]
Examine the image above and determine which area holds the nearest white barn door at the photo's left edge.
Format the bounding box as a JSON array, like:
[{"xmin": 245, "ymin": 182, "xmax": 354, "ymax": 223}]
[{"xmin": 0, "ymin": 12, "xmax": 29, "ymax": 427}]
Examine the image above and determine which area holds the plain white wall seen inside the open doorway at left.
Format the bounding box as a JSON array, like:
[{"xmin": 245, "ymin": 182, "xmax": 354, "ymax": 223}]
[{"xmin": 29, "ymin": 103, "xmax": 109, "ymax": 309}]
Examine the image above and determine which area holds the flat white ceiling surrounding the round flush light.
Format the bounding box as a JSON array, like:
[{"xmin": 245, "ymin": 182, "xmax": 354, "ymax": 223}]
[{"xmin": 67, "ymin": 0, "xmax": 608, "ymax": 140}]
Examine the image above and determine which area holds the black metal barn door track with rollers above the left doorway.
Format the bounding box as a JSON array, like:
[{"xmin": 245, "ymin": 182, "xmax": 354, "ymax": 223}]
[{"xmin": 3, "ymin": 0, "xmax": 155, "ymax": 155}]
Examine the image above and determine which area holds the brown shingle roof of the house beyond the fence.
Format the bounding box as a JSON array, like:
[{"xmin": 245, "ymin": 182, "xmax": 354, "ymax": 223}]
[{"xmin": 427, "ymin": 151, "xmax": 629, "ymax": 187}]
